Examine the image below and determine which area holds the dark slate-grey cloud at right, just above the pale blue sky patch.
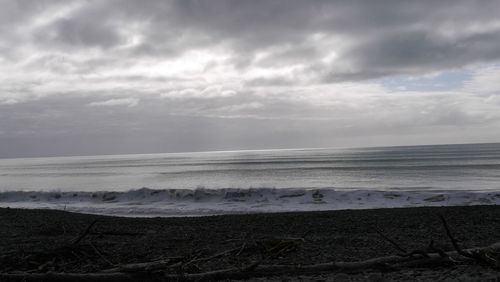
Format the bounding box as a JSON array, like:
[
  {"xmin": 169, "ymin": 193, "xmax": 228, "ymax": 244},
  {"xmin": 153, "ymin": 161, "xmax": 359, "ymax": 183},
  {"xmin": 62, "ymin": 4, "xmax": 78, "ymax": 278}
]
[{"xmin": 326, "ymin": 27, "xmax": 500, "ymax": 81}]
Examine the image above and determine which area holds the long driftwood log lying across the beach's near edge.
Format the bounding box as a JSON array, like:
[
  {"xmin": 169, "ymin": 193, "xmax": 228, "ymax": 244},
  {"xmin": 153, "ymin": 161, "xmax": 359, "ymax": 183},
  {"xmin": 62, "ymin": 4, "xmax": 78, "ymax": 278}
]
[{"xmin": 0, "ymin": 242, "xmax": 500, "ymax": 282}]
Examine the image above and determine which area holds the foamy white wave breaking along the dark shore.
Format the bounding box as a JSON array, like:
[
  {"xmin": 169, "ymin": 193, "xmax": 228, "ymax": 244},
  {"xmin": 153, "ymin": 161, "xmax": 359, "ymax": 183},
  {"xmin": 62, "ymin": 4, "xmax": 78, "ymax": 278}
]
[{"xmin": 0, "ymin": 188, "xmax": 500, "ymax": 216}]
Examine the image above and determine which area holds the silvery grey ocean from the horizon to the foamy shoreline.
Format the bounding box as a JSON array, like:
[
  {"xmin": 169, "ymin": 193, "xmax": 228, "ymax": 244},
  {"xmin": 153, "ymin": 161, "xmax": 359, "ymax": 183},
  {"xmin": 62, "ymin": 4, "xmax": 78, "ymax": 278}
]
[{"xmin": 0, "ymin": 143, "xmax": 500, "ymax": 216}]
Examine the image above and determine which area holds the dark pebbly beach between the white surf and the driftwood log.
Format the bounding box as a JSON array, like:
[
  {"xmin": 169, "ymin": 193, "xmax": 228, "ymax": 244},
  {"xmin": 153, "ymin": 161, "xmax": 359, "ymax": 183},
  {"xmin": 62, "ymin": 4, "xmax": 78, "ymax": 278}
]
[{"xmin": 0, "ymin": 206, "xmax": 500, "ymax": 281}]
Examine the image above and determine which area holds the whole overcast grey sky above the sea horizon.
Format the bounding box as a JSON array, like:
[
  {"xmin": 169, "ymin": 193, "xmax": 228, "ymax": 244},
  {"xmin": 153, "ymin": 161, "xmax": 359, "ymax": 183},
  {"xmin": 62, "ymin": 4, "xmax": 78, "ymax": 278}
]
[{"xmin": 0, "ymin": 0, "xmax": 500, "ymax": 158}]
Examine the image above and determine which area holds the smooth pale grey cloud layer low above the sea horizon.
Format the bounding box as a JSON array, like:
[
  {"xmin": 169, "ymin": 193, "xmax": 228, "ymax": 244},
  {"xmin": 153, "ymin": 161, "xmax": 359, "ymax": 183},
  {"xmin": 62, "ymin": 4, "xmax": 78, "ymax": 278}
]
[{"xmin": 0, "ymin": 82, "xmax": 500, "ymax": 157}]
